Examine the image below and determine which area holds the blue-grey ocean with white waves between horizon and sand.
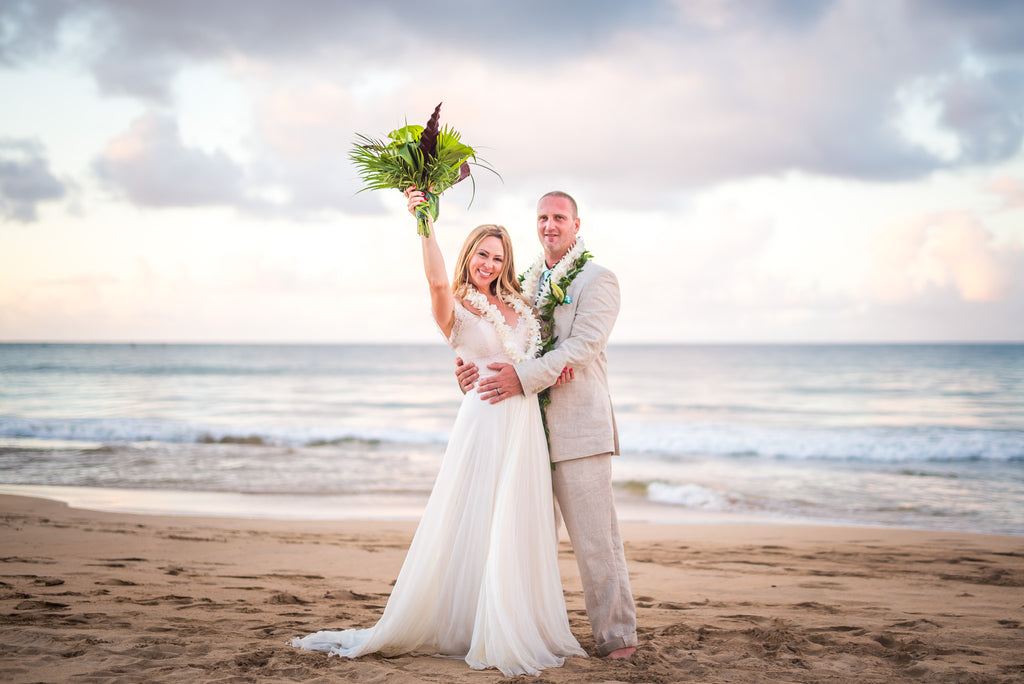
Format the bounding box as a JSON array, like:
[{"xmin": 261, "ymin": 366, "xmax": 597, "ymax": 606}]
[{"xmin": 0, "ymin": 342, "xmax": 1024, "ymax": 535}]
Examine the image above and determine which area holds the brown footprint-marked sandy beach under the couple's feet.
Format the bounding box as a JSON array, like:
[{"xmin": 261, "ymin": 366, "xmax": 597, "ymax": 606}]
[{"xmin": 0, "ymin": 496, "xmax": 1024, "ymax": 683}]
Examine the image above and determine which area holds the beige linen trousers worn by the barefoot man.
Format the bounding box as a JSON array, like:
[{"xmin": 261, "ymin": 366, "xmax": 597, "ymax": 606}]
[{"xmin": 551, "ymin": 454, "xmax": 637, "ymax": 655}]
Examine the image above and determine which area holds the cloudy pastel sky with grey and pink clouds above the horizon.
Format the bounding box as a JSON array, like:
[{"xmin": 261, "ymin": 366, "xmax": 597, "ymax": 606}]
[{"xmin": 0, "ymin": 0, "xmax": 1024, "ymax": 342}]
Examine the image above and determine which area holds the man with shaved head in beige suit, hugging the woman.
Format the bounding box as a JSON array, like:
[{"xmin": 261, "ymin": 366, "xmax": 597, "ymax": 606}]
[{"xmin": 458, "ymin": 190, "xmax": 637, "ymax": 658}]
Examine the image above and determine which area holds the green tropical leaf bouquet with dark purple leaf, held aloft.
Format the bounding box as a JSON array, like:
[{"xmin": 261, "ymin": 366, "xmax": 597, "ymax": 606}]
[{"xmin": 348, "ymin": 103, "xmax": 501, "ymax": 238}]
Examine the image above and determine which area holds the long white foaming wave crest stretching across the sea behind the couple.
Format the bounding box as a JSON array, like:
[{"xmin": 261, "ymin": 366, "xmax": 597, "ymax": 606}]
[{"xmin": 0, "ymin": 416, "xmax": 1024, "ymax": 463}]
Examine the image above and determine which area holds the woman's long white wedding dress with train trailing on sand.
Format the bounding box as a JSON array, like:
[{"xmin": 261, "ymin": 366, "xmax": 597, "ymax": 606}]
[{"xmin": 292, "ymin": 303, "xmax": 586, "ymax": 677}]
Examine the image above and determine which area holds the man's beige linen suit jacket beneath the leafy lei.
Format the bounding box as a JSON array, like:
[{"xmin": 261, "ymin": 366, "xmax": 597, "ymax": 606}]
[{"xmin": 515, "ymin": 261, "xmax": 620, "ymax": 462}]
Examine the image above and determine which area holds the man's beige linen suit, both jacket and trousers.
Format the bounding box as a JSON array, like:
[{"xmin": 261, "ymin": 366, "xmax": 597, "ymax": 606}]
[{"xmin": 515, "ymin": 261, "xmax": 637, "ymax": 655}]
